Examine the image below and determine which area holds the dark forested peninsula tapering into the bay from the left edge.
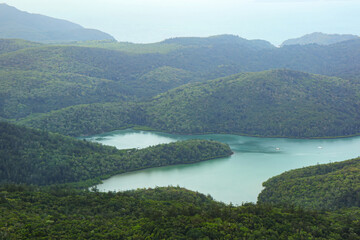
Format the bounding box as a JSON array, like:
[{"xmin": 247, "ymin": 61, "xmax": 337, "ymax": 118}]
[{"xmin": 0, "ymin": 123, "xmax": 232, "ymax": 185}]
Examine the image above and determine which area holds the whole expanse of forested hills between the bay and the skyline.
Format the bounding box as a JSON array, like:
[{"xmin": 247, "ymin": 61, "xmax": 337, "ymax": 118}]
[{"xmin": 0, "ymin": 35, "xmax": 360, "ymax": 137}]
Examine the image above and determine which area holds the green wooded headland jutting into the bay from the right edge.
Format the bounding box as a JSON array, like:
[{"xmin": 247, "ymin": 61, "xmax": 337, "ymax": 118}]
[{"xmin": 258, "ymin": 158, "xmax": 360, "ymax": 209}]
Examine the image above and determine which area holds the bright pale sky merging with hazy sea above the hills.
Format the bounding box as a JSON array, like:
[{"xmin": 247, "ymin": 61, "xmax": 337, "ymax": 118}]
[{"xmin": 0, "ymin": 0, "xmax": 360, "ymax": 45}]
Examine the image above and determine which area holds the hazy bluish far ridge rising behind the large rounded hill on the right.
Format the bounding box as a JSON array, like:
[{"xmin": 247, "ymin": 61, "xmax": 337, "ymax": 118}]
[{"xmin": 69, "ymin": 35, "xmax": 360, "ymax": 81}]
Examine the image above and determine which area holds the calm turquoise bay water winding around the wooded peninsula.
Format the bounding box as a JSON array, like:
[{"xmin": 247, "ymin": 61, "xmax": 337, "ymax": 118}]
[{"xmin": 87, "ymin": 130, "xmax": 360, "ymax": 204}]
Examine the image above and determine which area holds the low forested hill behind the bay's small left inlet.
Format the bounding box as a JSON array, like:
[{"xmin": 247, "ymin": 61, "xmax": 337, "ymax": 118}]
[{"xmin": 17, "ymin": 102, "xmax": 145, "ymax": 137}]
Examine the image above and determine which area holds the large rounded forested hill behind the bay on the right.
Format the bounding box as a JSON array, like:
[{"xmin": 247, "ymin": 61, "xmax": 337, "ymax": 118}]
[{"xmin": 147, "ymin": 70, "xmax": 360, "ymax": 137}]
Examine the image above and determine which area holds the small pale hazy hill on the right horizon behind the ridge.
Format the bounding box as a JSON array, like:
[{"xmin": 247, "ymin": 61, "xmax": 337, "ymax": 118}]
[{"xmin": 281, "ymin": 32, "xmax": 359, "ymax": 46}]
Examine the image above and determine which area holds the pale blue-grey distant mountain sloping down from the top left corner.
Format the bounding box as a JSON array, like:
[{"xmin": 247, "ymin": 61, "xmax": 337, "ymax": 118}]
[{"xmin": 0, "ymin": 3, "xmax": 114, "ymax": 42}]
